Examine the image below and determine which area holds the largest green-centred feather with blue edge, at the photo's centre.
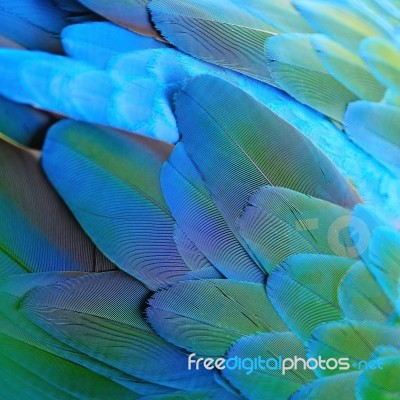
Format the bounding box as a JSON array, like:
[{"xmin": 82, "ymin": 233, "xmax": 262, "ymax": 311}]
[{"xmin": 175, "ymin": 76, "xmax": 359, "ymax": 245}]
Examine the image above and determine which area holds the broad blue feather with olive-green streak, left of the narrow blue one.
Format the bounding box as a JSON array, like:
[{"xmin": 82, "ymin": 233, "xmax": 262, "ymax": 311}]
[{"xmin": 43, "ymin": 121, "xmax": 189, "ymax": 289}]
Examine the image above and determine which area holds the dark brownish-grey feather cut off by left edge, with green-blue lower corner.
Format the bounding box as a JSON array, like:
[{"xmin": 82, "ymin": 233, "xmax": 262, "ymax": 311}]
[{"xmin": 0, "ymin": 139, "xmax": 115, "ymax": 275}]
